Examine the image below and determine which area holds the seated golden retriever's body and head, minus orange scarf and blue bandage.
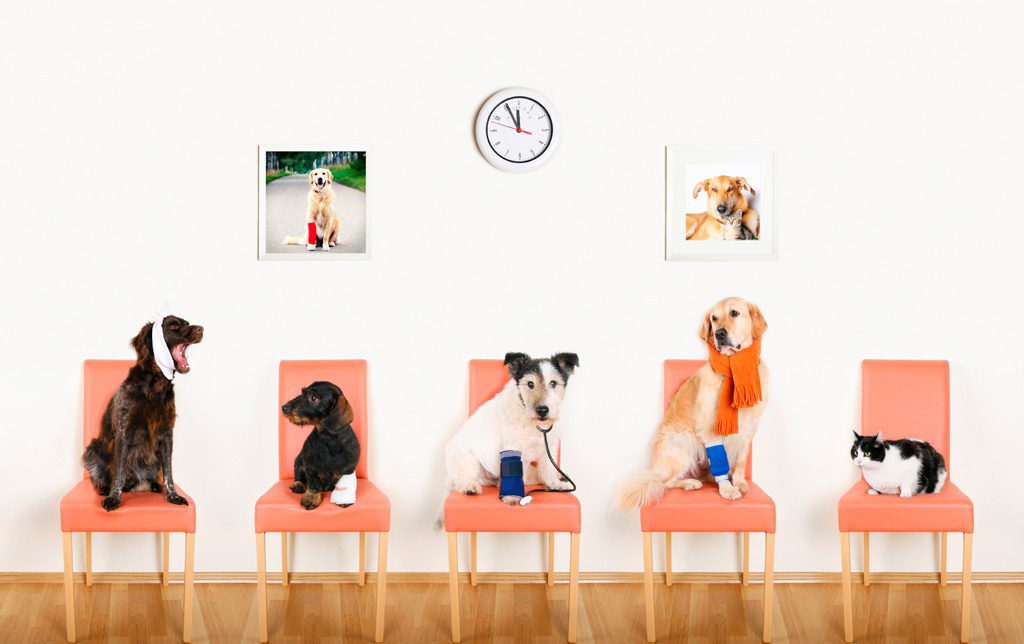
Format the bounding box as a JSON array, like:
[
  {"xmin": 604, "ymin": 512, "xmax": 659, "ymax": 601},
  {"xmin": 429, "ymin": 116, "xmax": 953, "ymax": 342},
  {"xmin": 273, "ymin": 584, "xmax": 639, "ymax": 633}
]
[{"xmin": 618, "ymin": 297, "xmax": 768, "ymax": 509}]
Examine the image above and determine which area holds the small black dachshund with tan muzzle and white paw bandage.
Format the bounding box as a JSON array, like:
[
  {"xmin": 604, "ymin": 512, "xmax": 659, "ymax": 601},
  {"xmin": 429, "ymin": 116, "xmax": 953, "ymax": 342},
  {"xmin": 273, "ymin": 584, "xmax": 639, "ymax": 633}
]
[{"xmin": 281, "ymin": 382, "xmax": 359, "ymax": 510}]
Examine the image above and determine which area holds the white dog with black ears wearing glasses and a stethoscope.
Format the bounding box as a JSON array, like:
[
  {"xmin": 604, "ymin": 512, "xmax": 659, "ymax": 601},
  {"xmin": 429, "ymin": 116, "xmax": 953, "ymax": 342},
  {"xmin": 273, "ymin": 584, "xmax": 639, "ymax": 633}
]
[{"xmin": 444, "ymin": 353, "xmax": 580, "ymax": 505}]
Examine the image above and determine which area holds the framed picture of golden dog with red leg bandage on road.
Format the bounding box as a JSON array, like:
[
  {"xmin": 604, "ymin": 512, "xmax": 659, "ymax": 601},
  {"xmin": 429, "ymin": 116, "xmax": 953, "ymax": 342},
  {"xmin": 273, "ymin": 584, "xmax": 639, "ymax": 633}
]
[{"xmin": 258, "ymin": 145, "xmax": 370, "ymax": 261}]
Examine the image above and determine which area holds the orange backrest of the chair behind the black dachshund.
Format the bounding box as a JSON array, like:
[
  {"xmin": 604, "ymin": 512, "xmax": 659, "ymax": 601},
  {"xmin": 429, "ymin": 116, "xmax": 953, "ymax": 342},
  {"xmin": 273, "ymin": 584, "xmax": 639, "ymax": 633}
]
[{"xmin": 276, "ymin": 360, "xmax": 370, "ymax": 479}]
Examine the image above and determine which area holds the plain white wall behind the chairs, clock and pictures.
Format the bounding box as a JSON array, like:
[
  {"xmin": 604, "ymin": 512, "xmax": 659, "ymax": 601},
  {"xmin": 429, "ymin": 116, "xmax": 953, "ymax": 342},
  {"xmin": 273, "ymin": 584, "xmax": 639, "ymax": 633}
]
[{"xmin": 0, "ymin": 2, "xmax": 1024, "ymax": 571}]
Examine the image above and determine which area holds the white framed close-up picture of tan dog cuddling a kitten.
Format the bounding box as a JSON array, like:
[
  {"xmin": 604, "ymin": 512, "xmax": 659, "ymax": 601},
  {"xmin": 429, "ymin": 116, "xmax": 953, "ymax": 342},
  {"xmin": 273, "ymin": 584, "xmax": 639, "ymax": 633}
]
[{"xmin": 665, "ymin": 145, "xmax": 778, "ymax": 261}]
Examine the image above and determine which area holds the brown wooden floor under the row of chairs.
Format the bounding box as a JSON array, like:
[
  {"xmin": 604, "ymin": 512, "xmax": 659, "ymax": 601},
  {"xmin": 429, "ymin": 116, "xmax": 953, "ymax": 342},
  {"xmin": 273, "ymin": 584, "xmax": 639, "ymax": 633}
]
[{"xmin": 0, "ymin": 575, "xmax": 1024, "ymax": 644}]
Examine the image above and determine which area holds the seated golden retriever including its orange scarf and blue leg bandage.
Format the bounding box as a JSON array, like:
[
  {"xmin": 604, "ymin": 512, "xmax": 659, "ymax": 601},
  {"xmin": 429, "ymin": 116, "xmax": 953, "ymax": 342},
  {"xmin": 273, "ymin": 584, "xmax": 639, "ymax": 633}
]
[{"xmin": 618, "ymin": 297, "xmax": 768, "ymax": 510}]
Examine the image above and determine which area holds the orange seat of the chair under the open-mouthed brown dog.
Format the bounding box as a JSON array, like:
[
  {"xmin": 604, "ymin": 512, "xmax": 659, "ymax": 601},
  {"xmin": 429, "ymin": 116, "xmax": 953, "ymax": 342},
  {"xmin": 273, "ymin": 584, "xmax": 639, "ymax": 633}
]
[{"xmin": 60, "ymin": 479, "xmax": 196, "ymax": 532}]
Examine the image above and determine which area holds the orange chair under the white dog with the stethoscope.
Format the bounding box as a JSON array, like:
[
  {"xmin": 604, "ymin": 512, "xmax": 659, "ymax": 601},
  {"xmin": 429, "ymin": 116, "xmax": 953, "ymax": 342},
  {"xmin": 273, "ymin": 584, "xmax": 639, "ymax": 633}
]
[{"xmin": 444, "ymin": 360, "xmax": 580, "ymax": 642}]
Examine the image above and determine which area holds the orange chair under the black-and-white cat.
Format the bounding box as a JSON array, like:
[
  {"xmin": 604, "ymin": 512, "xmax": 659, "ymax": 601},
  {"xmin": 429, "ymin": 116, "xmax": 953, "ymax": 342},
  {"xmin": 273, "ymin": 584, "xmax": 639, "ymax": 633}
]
[{"xmin": 839, "ymin": 360, "xmax": 974, "ymax": 642}]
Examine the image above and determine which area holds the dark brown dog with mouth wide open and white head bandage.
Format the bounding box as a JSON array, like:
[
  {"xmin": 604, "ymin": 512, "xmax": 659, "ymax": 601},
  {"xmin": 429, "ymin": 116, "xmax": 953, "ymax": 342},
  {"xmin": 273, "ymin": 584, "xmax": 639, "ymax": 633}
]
[{"xmin": 82, "ymin": 315, "xmax": 203, "ymax": 512}]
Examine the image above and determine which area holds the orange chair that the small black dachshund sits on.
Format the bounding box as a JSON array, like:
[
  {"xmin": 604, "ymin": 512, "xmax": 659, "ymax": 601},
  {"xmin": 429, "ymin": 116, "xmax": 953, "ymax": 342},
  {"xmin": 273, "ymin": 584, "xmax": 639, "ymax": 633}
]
[{"xmin": 256, "ymin": 360, "xmax": 391, "ymax": 642}]
